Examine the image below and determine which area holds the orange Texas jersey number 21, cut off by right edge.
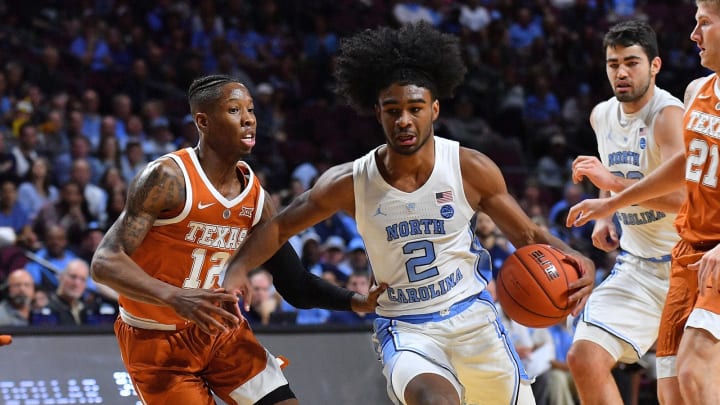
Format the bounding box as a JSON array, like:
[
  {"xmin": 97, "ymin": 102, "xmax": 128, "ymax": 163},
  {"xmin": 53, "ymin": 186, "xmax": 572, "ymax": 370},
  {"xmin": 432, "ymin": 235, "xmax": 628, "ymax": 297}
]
[{"xmin": 675, "ymin": 74, "xmax": 720, "ymax": 244}]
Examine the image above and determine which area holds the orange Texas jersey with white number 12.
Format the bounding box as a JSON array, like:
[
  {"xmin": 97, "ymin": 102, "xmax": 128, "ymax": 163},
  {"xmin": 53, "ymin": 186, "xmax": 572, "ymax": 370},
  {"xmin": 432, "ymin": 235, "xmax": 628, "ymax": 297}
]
[{"xmin": 120, "ymin": 148, "xmax": 264, "ymax": 329}]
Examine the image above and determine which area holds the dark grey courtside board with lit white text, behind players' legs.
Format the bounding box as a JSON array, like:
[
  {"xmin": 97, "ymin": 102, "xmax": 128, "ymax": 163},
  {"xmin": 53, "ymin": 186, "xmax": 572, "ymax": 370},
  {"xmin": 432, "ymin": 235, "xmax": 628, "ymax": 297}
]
[{"xmin": 0, "ymin": 331, "xmax": 391, "ymax": 405}]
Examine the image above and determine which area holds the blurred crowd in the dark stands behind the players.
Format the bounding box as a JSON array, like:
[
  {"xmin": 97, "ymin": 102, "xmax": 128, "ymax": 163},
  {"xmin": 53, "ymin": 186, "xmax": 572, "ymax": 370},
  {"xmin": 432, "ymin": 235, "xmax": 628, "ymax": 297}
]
[{"xmin": 0, "ymin": 0, "xmax": 703, "ymax": 400}]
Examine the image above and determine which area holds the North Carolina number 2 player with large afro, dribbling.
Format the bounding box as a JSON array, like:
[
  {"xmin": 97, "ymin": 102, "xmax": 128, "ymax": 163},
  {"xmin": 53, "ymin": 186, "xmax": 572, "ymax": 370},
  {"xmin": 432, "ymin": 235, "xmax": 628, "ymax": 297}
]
[{"xmin": 223, "ymin": 23, "xmax": 595, "ymax": 405}]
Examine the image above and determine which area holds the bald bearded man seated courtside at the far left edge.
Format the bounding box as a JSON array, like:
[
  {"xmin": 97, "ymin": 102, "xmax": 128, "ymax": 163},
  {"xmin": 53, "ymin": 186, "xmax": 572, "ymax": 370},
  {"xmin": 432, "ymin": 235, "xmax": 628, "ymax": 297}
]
[{"xmin": 0, "ymin": 269, "xmax": 35, "ymax": 326}]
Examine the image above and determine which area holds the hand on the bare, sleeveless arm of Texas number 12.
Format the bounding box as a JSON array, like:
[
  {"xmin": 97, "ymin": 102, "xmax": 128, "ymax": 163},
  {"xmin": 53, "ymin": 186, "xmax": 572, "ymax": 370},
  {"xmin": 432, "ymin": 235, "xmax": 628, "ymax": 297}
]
[{"xmin": 169, "ymin": 288, "xmax": 240, "ymax": 334}]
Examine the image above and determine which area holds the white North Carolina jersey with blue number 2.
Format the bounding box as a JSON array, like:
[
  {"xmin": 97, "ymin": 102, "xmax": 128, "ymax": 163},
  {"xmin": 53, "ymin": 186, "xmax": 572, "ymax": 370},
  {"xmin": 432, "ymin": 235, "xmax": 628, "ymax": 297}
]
[{"xmin": 353, "ymin": 136, "xmax": 486, "ymax": 317}]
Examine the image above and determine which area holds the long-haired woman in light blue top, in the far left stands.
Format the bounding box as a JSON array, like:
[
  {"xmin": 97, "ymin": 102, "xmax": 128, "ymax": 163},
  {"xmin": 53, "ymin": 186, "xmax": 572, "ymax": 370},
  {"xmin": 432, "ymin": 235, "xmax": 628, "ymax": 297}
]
[{"xmin": 18, "ymin": 157, "xmax": 59, "ymax": 221}]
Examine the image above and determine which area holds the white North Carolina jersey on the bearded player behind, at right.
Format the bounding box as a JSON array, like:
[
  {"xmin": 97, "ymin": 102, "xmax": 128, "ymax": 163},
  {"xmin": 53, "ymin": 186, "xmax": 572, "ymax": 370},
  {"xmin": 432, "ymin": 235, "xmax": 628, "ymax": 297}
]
[{"xmin": 591, "ymin": 87, "xmax": 683, "ymax": 258}]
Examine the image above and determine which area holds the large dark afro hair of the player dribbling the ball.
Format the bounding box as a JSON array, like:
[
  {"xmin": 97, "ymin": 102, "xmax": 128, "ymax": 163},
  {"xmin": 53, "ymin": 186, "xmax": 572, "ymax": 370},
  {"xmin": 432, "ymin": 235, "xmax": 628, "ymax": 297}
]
[{"xmin": 334, "ymin": 22, "xmax": 467, "ymax": 112}]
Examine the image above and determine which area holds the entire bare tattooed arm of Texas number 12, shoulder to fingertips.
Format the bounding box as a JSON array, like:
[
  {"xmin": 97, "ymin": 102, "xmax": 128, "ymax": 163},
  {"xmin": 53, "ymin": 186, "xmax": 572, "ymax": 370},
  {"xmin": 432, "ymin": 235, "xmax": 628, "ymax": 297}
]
[{"xmin": 91, "ymin": 159, "xmax": 239, "ymax": 333}]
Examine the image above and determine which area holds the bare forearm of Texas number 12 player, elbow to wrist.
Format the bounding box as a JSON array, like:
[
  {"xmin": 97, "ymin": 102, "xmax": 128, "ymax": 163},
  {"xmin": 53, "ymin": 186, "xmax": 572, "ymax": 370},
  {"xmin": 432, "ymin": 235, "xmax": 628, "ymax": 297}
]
[{"xmin": 90, "ymin": 249, "xmax": 179, "ymax": 306}]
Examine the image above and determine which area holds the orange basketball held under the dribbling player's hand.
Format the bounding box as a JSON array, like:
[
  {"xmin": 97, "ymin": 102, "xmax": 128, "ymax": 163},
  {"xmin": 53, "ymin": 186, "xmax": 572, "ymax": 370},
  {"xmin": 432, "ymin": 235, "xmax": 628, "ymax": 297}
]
[{"xmin": 497, "ymin": 244, "xmax": 579, "ymax": 328}]
